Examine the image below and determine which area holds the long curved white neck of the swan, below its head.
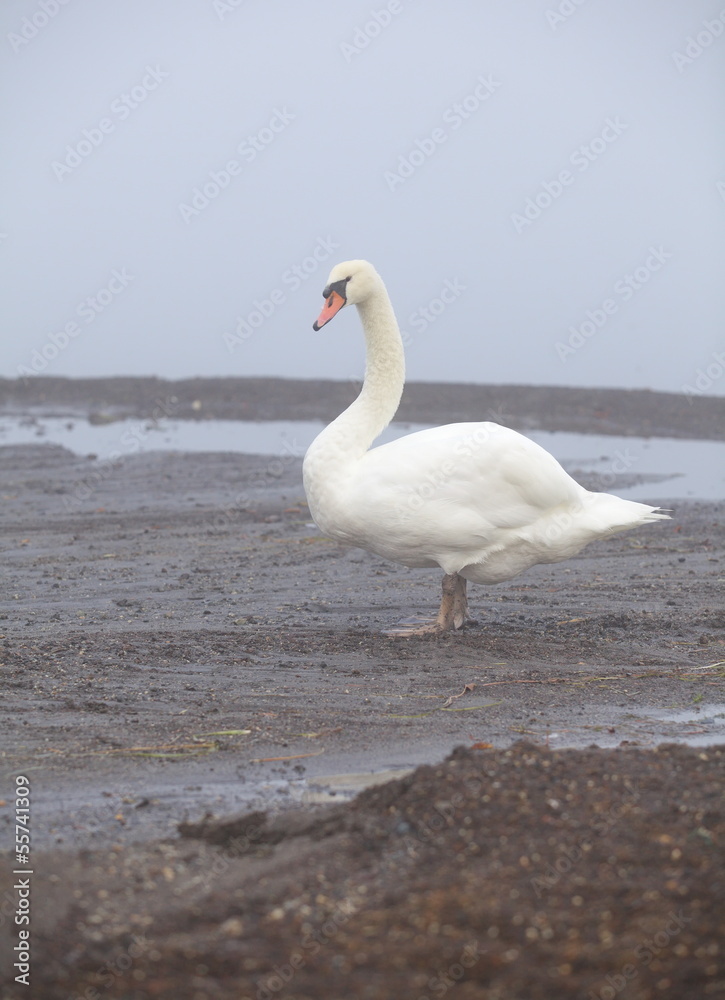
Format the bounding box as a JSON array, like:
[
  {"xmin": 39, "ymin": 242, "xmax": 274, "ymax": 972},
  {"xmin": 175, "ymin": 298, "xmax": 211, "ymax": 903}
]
[{"xmin": 315, "ymin": 281, "xmax": 405, "ymax": 461}]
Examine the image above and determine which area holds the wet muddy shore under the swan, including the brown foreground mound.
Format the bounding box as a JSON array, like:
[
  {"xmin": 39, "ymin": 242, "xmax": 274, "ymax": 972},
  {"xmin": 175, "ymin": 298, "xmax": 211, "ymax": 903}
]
[{"xmin": 0, "ymin": 380, "xmax": 725, "ymax": 1000}]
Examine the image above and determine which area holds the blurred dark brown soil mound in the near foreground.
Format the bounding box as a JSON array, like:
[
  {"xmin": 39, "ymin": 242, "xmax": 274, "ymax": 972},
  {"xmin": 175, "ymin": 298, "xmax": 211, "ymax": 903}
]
[{"xmin": 15, "ymin": 742, "xmax": 725, "ymax": 1000}]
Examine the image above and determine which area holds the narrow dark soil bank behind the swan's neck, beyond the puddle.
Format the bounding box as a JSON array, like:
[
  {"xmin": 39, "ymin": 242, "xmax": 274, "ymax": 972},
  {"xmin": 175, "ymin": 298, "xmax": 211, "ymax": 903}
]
[{"xmin": 0, "ymin": 376, "xmax": 725, "ymax": 441}]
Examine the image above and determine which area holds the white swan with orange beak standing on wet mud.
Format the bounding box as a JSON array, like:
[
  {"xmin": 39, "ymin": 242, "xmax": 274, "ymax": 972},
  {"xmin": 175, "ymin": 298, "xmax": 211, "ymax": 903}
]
[{"xmin": 303, "ymin": 260, "xmax": 668, "ymax": 634}]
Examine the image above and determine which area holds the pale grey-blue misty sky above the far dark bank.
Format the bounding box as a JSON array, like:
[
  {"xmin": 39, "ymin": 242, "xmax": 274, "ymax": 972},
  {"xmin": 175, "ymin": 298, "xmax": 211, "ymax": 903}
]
[{"xmin": 0, "ymin": 0, "xmax": 725, "ymax": 393}]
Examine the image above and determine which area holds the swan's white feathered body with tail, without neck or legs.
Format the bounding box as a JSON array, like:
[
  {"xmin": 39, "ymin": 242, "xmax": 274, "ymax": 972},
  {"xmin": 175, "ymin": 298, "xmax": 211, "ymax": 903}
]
[{"xmin": 308, "ymin": 423, "xmax": 666, "ymax": 583}]
